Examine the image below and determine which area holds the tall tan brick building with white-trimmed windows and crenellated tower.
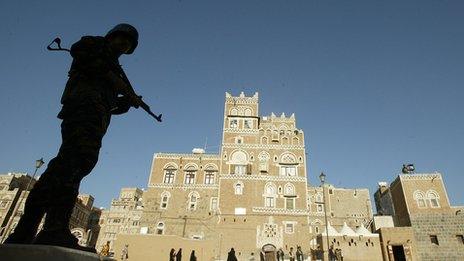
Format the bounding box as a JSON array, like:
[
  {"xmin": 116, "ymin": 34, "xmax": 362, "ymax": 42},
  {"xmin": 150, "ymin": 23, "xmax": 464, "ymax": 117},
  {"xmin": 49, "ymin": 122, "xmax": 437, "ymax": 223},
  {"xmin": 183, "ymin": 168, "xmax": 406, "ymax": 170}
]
[{"xmin": 118, "ymin": 93, "xmax": 372, "ymax": 258}]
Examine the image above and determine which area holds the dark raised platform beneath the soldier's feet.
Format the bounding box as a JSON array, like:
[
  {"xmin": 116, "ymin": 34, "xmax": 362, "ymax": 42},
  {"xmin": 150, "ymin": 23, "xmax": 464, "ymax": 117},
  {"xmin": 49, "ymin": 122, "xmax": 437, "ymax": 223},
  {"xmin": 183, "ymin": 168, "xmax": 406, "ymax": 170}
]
[{"xmin": 0, "ymin": 244, "xmax": 114, "ymax": 261}]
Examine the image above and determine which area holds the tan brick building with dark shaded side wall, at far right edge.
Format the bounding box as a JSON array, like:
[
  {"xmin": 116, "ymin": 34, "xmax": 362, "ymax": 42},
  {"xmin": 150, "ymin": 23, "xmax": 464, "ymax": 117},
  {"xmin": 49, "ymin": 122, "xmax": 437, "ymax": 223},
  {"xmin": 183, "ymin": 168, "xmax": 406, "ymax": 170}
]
[{"xmin": 375, "ymin": 173, "xmax": 464, "ymax": 261}]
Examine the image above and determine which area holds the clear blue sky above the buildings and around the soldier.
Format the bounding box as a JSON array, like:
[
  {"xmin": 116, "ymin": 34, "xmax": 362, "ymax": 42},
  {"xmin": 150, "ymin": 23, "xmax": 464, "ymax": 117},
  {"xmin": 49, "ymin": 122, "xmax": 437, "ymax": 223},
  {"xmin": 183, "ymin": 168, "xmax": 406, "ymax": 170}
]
[{"xmin": 0, "ymin": 0, "xmax": 464, "ymax": 207}]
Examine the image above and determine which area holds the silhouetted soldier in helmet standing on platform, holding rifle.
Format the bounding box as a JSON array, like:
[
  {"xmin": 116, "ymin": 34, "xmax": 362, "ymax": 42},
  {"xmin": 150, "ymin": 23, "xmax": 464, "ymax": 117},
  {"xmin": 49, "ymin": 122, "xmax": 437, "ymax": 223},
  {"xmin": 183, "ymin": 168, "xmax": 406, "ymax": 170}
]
[{"xmin": 5, "ymin": 24, "xmax": 141, "ymax": 251}]
